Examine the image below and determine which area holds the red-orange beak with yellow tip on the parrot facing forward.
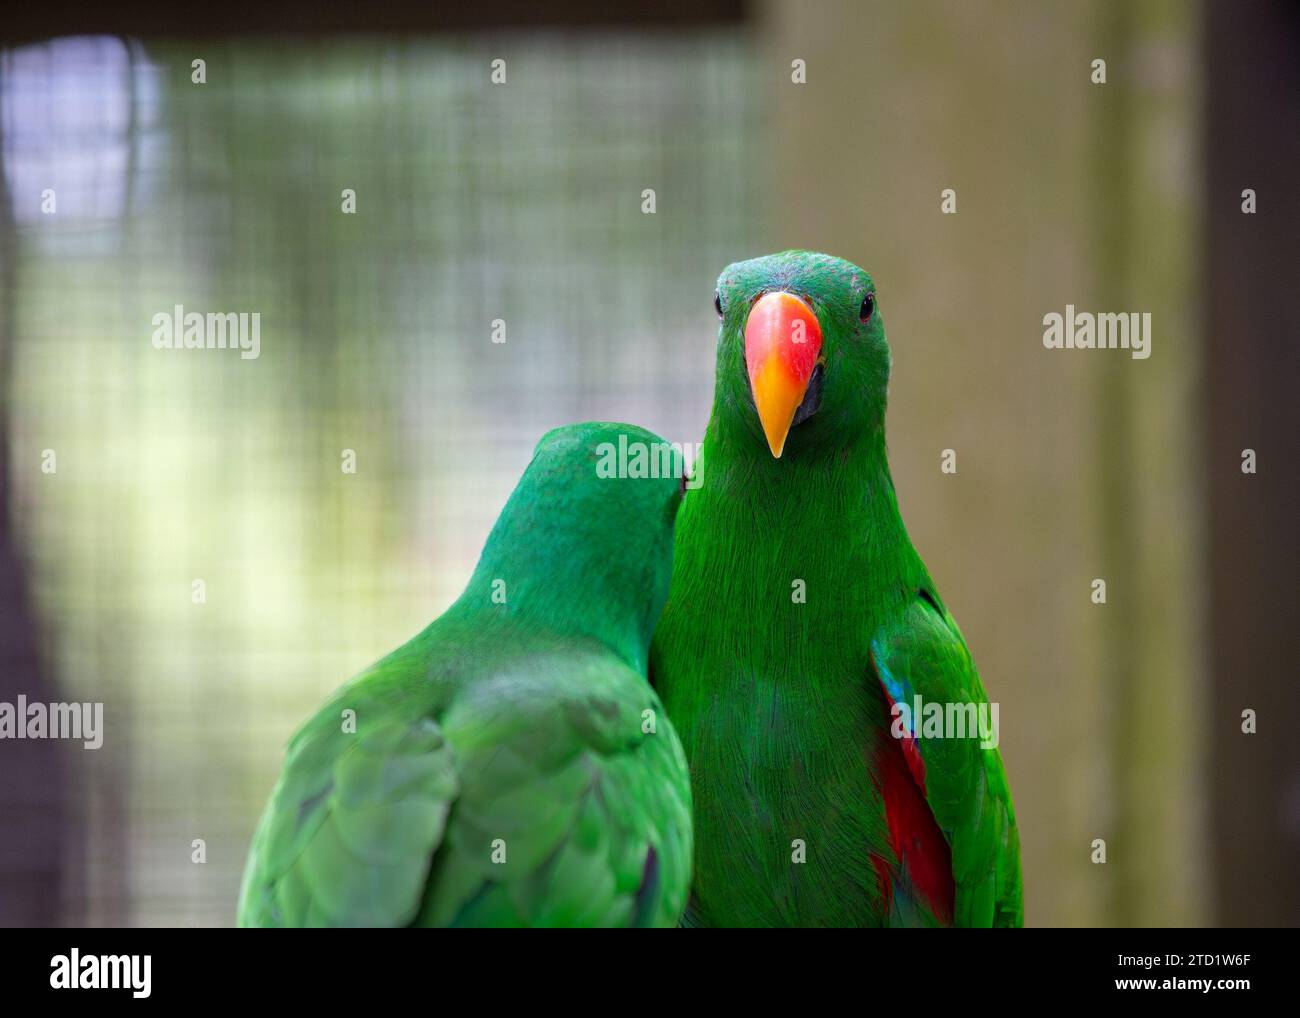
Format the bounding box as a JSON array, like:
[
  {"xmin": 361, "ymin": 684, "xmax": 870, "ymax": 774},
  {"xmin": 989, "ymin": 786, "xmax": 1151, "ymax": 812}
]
[{"xmin": 745, "ymin": 293, "xmax": 822, "ymax": 459}]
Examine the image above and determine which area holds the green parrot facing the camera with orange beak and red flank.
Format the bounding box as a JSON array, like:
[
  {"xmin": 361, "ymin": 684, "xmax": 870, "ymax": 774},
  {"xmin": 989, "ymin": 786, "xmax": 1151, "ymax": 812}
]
[{"xmin": 650, "ymin": 251, "xmax": 1023, "ymax": 926}]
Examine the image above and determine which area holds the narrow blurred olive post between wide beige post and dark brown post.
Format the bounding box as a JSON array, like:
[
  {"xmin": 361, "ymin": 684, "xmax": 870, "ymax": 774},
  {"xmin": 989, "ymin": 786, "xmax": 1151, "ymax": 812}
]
[{"xmin": 1089, "ymin": 0, "xmax": 1209, "ymax": 926}]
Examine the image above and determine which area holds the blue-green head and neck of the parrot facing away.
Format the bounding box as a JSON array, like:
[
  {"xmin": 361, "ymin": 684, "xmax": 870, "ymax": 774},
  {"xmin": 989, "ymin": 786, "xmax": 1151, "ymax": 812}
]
[{"xmin": 460, "ymin": 423, "xmax": 684, "ymax": 671}]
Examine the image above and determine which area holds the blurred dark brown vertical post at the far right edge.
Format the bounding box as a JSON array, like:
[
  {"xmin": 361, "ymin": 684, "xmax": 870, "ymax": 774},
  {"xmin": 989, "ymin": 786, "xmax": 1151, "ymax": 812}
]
[{"xmin": 1197, "ymin": 0, "xmax": 1300, "ymax": 926}]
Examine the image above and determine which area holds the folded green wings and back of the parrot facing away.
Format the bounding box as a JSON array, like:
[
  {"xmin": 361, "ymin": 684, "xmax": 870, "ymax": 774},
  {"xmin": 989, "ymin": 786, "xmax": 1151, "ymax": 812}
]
[{"xmin": 239, "ymin": 658, "xmax": 692, "ymax": 926}]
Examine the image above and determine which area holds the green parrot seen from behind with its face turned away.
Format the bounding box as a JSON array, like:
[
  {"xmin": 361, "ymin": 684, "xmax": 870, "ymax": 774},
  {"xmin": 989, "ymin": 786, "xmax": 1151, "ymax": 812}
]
[{"xmin": 238, "ymin": 424, "xmax": 692, "ymax": 926}]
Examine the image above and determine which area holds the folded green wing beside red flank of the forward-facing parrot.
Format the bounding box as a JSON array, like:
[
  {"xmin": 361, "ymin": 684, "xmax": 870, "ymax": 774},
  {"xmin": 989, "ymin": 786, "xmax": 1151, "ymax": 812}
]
[{"xmin": 871, "ymin": 593, "xmax": 1024, "ymax": 926}]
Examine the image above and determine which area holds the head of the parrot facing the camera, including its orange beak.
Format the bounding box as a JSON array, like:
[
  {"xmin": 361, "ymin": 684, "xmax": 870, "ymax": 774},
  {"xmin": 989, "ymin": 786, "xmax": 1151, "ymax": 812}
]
[{"xmin": 714, "ymin": 251, "xmax": 889, "ymax": 458}]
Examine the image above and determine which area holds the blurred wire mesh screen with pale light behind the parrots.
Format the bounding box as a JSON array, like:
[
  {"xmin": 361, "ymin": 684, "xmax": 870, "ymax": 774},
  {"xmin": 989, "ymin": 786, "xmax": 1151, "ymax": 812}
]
[{"xmin": 0, "ymin": 30, "xmax": 764, "ymax": 924}]
